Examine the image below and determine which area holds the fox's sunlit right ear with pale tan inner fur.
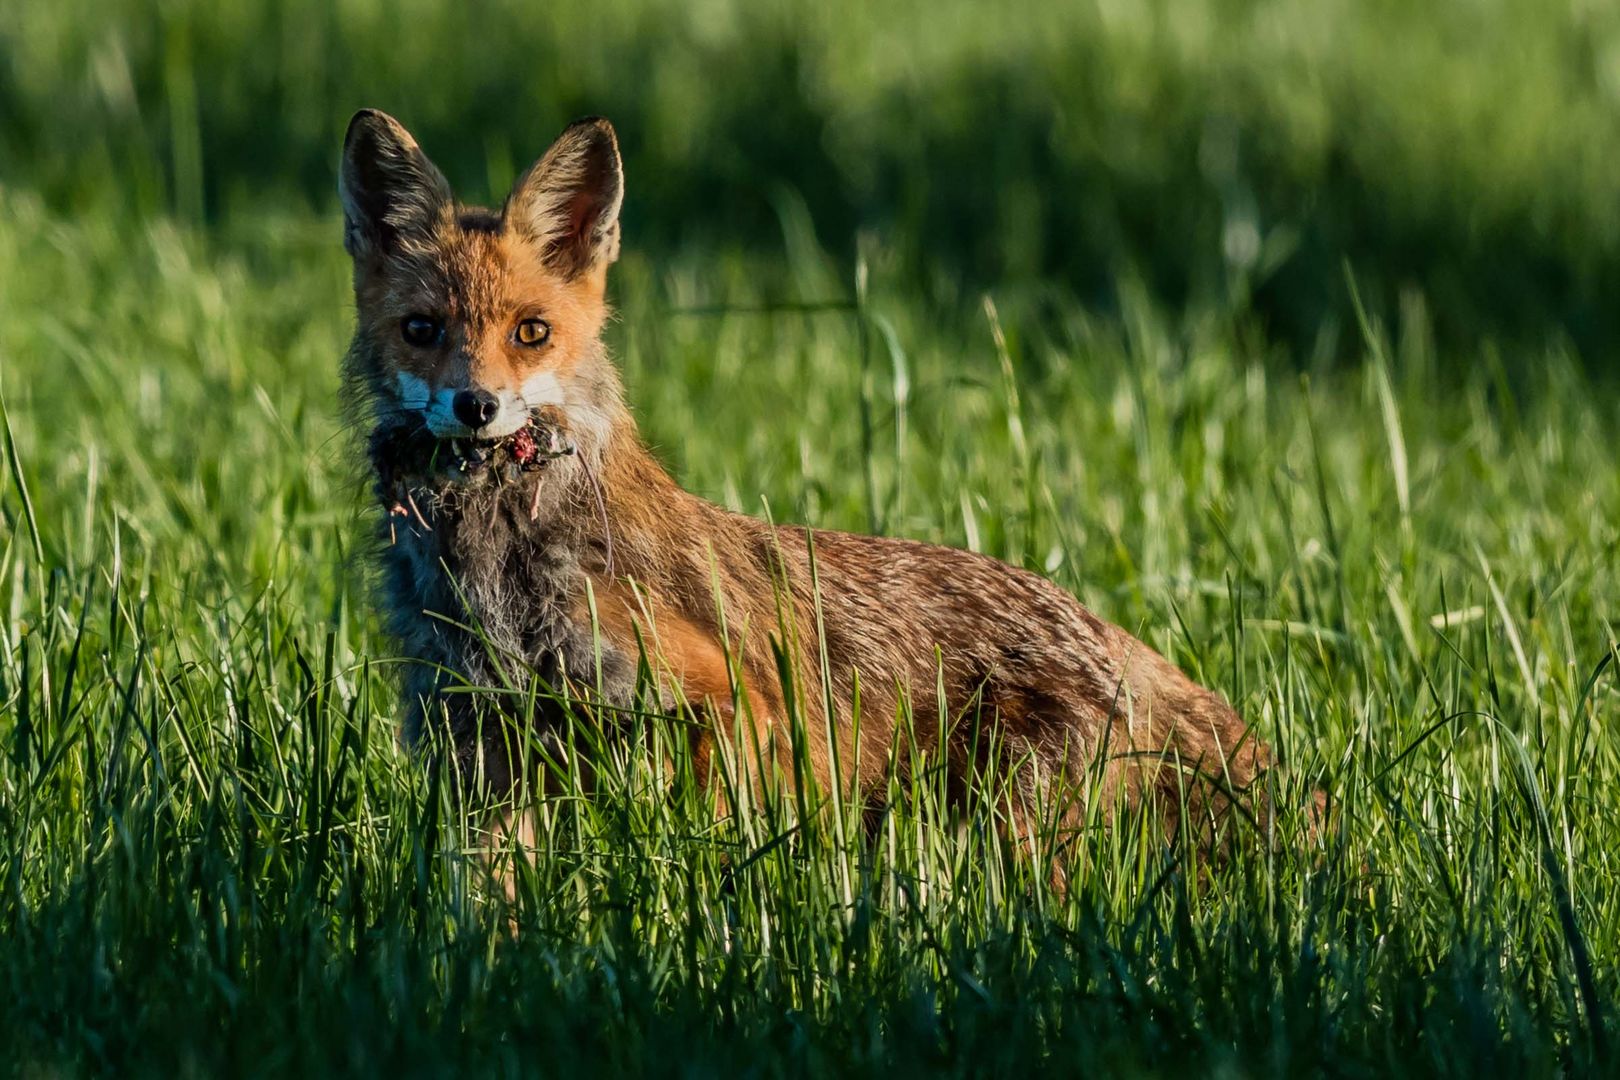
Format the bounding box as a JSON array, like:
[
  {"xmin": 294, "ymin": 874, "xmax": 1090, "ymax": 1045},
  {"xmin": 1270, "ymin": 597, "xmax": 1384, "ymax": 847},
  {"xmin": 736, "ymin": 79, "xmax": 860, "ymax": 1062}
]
[{"xmin": 505, "ymin": 117, "xmax": 624, "ymax": 277}]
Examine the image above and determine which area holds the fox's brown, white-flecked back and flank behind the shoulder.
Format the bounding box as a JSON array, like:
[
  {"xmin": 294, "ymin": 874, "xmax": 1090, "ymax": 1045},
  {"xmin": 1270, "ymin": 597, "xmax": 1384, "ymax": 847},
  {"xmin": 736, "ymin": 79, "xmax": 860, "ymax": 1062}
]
[{"xmin": 677, "ymin": 498, "xmax": 1264, "ymax": 803}]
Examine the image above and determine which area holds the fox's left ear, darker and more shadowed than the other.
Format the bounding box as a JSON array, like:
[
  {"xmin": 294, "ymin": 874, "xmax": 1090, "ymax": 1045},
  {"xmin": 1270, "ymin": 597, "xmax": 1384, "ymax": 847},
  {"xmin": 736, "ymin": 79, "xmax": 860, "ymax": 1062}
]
[{"xmin": 337, "ymin": 108, "xmax": 454, "ymax": 259}]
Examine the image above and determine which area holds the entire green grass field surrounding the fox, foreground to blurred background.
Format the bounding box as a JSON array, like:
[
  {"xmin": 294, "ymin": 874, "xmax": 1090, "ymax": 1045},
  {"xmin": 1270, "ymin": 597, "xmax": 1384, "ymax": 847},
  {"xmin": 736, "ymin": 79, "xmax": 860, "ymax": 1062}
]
[{"xmin": 0, "ymin": 0, "xmax": 1620, "ymax": 1075}]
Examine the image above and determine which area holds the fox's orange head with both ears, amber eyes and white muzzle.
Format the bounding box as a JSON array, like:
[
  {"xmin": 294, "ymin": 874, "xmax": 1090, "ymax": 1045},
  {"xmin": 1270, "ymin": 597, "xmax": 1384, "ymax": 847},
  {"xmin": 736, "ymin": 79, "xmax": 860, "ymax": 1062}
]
[{"xmin": 339, "ymin": 110, "xmax": 624, "ymax": 453}]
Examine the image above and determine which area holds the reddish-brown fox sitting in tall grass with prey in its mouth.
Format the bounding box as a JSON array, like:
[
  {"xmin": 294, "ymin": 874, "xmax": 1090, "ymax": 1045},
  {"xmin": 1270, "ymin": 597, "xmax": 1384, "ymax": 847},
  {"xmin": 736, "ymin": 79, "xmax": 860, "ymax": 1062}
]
[{"xmin": 339, "ymin": 110, "xmax": 1273, "ymax": 867}]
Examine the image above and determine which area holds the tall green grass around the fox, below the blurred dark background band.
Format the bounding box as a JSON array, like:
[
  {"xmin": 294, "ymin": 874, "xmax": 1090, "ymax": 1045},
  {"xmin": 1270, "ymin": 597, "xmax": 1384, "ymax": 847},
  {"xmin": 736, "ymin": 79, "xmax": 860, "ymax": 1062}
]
[{"xmin": 0, "ymin": 170, "xmax": 1620, "ymax": 1074}]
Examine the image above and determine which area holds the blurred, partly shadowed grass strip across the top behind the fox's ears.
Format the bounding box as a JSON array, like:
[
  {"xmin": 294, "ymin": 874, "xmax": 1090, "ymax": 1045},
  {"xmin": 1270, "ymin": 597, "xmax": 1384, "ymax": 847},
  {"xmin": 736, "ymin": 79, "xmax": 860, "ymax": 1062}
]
[{"xmin": 9, "ymin": 0, "xmax": 1620, "ymax": 358}]
